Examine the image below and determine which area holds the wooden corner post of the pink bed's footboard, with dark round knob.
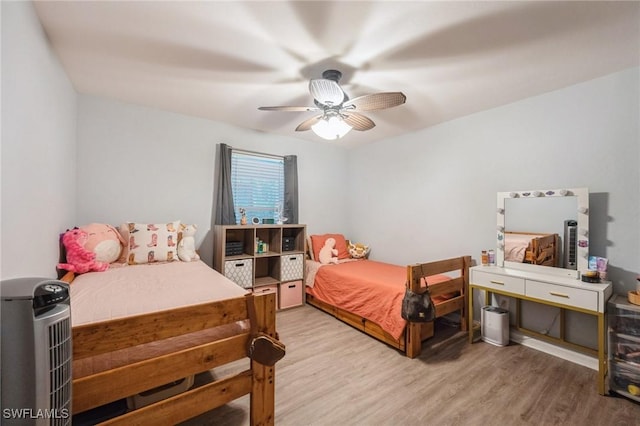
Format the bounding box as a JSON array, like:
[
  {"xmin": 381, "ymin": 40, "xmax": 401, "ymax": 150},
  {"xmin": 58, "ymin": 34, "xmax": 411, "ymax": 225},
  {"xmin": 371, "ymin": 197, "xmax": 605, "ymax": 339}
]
[{"xmin": 250, "ymin": 293, "xmax": 277, "ymax": 426}]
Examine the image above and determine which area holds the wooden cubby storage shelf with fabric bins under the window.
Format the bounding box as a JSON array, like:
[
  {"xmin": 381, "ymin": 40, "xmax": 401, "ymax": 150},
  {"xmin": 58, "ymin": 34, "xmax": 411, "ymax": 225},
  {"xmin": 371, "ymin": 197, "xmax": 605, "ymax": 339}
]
[{"xmin": 213, "ymin": 225, "xmax": 306, "ymax": 309}]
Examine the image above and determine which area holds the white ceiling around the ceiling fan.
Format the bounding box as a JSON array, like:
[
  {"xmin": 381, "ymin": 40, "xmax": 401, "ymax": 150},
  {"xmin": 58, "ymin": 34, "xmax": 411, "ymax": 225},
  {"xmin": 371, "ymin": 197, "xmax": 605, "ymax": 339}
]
[{"xmin": 36, "ymin": 1, "xmax": 640, "ymax": 146}]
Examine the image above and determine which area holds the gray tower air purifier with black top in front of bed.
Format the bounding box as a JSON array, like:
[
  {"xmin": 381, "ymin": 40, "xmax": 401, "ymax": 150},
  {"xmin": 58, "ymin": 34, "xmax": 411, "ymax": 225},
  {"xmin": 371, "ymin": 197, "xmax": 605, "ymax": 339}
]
[{"xmin": 0, "ymin": 278, "xmax": 72, "ymax": 426}]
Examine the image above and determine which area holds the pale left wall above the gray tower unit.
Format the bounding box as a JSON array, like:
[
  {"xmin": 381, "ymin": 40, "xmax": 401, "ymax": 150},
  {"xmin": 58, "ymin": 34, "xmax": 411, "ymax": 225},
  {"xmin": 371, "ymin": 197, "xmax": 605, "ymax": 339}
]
[{"xmin": 0, "ymin": 2, "xmax": 76, "ymax": 279}]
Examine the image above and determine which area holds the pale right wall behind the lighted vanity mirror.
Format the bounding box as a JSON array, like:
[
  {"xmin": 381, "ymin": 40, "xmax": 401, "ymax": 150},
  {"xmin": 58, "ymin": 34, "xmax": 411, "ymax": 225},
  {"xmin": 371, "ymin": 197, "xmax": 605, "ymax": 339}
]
[{"xmin": 349, "ymin": 68, "xmax": 640, "ymax": 293}]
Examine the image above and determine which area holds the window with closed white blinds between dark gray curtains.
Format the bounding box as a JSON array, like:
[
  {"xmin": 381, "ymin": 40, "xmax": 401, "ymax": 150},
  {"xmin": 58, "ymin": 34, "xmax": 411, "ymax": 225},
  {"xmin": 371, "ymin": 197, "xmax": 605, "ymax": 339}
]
[{"xmin": 231, "ymin": 149, "xmax": 284, "ymax": 223}]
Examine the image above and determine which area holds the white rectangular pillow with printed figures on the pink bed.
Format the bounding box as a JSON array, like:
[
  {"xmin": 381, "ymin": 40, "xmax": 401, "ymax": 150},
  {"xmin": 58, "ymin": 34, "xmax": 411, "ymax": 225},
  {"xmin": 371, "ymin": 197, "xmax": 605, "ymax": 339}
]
[{"xmin": 127, "ymin": 220, "xmax": 180, "ymax": 265}]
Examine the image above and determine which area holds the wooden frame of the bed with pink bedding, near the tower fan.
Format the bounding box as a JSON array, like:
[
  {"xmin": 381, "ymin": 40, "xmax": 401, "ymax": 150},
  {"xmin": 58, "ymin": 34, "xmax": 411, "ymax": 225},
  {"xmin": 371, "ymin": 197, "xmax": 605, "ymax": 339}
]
[{"xmin": 62, "ymin": 273, "xmax": 276, "ymax": 425}]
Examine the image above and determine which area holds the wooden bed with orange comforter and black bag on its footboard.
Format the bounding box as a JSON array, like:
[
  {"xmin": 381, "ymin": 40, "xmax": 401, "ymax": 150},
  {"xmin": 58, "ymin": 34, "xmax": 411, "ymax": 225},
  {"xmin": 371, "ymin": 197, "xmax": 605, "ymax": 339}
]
[{"xmin": 305, "ymin": 256, "xmax": 471, "ymax": 358}]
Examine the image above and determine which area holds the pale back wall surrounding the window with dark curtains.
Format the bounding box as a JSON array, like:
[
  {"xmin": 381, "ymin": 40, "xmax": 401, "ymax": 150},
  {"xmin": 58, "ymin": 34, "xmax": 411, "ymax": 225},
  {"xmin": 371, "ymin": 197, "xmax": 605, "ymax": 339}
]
[{"xmin": 77, "ymin": 96, "xmax": 348, "ymax": 264}]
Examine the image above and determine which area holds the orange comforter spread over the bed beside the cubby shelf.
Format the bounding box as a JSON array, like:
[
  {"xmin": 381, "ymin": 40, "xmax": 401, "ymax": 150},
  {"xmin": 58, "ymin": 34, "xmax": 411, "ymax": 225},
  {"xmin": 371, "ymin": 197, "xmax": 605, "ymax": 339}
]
[{"xmin": 306, "ymin": 260, "xmax": 450, "ymax": 339}]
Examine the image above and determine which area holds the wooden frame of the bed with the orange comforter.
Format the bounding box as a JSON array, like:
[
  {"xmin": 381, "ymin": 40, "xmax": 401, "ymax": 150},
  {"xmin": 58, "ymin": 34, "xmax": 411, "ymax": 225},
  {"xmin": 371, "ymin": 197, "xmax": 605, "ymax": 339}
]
[{"xmin": 307, "ymin": 256, "xmax": 471, "ymax": 358}]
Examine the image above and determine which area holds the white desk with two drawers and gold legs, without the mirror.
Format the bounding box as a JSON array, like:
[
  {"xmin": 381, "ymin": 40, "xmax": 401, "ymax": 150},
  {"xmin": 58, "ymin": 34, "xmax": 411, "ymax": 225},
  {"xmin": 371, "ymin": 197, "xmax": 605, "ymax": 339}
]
[{"xmin": 469, "ymin": 266, "xmax": 613, "ymax": 395}]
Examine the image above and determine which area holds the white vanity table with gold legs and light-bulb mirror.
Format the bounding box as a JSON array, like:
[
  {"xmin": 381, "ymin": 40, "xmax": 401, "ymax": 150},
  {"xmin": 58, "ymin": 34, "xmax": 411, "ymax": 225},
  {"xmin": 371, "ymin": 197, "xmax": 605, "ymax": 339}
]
[{"xmin": 468, "ymin": 188, "xmax": 613, "ymax": 395}]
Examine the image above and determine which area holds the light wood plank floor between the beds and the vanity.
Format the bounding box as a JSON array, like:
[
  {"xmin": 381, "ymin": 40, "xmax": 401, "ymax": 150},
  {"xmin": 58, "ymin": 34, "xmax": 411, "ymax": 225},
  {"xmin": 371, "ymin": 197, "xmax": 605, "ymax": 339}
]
[{"xmin": 184, "ymin": 306, "xmax": 640, "ymax": 426}]
